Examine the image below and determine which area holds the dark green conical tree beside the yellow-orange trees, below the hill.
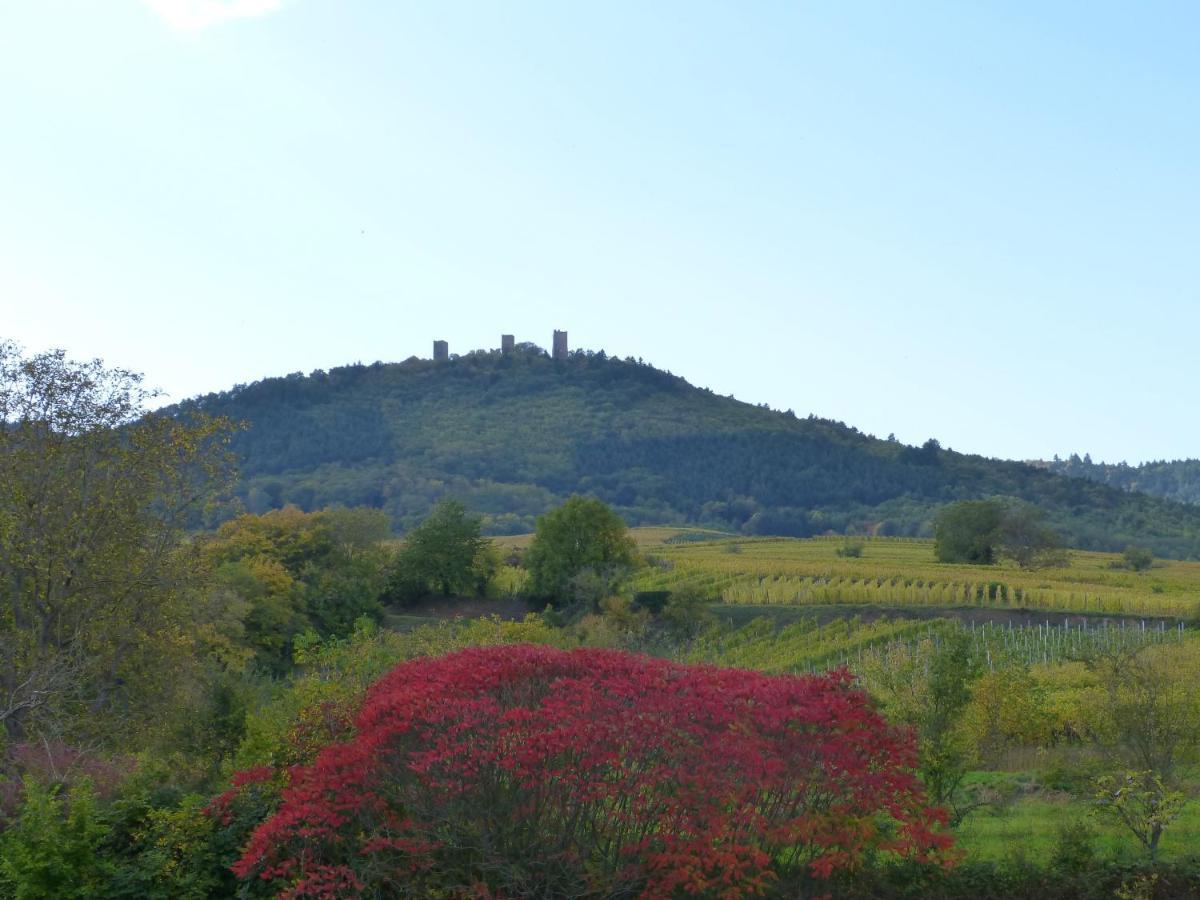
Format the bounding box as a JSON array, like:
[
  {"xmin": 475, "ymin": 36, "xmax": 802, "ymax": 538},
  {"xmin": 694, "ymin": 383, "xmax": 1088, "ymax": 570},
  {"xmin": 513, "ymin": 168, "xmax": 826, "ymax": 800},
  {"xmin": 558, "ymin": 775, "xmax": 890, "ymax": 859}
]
[{"xmin": 390, "ymin": 499, "xmax": 498, "ymax": 602}]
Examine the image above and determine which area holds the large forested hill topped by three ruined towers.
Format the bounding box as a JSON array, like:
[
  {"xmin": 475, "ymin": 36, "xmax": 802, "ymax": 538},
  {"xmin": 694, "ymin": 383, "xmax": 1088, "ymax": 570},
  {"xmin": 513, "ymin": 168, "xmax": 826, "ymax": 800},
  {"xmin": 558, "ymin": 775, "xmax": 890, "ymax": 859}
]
[{"xmin": 174, "ymin": 344, "xmax": 1200, "ymax": 557}]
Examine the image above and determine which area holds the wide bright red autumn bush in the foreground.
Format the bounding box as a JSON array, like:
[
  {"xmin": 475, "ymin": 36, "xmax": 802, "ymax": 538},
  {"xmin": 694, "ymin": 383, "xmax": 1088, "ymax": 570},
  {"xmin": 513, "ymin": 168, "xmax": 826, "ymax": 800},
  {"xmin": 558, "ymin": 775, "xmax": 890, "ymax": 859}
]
[{"xmin": 234, "ymin": 646, "xmax": 949, "ymax": 898}]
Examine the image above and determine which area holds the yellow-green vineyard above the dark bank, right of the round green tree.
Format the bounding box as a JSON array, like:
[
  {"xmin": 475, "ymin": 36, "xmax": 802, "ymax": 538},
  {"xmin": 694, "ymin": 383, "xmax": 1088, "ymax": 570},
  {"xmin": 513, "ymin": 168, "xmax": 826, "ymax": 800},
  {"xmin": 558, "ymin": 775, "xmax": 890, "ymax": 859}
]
[{"xmin": 636, "ymin": 538, "xmax": 1200, "ymax": 619}]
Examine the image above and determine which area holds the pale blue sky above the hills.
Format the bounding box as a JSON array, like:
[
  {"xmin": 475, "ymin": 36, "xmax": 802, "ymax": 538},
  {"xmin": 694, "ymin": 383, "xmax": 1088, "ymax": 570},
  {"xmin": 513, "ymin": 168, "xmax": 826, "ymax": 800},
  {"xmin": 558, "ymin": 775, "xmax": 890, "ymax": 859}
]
[{"xmin": 0, "ymin": 0, "xmax": 1200, "ymax": 462}]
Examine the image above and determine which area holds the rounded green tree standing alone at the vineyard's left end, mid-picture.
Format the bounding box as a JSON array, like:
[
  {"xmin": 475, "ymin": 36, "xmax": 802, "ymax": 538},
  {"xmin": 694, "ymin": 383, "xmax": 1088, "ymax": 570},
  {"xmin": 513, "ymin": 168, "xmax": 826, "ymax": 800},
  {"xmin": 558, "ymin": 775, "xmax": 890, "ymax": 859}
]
[{"xmin": 524, "ymin": 496, "xmax": 637, "ymax": 606}]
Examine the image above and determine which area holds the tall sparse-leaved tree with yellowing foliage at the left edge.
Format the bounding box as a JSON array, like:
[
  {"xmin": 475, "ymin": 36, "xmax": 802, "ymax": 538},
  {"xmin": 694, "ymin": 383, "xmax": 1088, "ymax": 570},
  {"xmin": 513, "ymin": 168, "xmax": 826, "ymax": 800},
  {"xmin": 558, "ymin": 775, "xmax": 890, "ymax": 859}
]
[{"xmin": 0, "ymin": 342, "xmax": 230, "ymax": 739}]
